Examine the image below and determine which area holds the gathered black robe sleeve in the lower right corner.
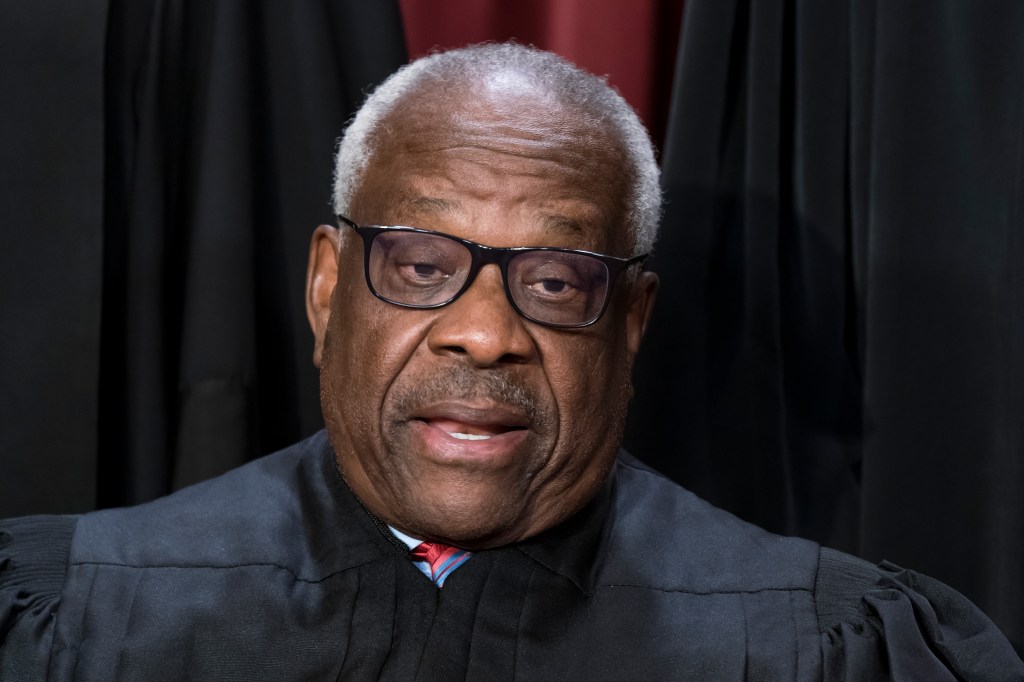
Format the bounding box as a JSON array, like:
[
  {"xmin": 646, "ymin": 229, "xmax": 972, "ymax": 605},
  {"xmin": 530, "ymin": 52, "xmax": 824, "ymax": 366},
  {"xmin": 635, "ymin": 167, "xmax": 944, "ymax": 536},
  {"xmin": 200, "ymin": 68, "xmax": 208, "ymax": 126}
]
[{"xmin": 815, "ymin": 549, "xmax": 1024, "ymax": 681}]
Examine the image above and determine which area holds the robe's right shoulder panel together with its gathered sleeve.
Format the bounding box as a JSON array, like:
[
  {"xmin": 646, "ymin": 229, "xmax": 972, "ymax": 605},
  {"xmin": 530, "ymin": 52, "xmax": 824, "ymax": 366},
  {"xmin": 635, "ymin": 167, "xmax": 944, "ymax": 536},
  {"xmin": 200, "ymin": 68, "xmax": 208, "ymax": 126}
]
[{"xmin": 602, "ymin": 454, "xmax": 1024, "ymax": 680}]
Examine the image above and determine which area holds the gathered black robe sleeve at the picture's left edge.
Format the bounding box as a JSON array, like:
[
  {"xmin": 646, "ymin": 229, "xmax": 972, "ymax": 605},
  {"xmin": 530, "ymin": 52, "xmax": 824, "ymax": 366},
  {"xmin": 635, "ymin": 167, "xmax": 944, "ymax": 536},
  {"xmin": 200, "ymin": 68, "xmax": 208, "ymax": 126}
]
[{"xmin": 0, "ymin": 516, "xmax": 77, "ymax": 681}]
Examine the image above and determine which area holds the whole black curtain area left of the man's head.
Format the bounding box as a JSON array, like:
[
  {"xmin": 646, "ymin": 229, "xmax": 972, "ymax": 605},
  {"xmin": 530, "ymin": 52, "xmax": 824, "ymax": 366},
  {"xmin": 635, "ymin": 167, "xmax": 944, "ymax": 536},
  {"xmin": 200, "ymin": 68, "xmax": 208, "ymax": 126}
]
[{"xmin": 0, "ymin": 0, "xmax": 406, "ymax": 509}]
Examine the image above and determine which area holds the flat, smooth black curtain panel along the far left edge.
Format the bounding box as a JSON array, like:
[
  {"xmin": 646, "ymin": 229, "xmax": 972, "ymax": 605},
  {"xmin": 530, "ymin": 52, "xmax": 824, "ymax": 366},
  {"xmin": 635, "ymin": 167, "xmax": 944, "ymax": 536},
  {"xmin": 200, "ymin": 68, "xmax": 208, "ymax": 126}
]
[{"xmin": 0, "ymin": 0, "xmax": 108, "ymax": 516}]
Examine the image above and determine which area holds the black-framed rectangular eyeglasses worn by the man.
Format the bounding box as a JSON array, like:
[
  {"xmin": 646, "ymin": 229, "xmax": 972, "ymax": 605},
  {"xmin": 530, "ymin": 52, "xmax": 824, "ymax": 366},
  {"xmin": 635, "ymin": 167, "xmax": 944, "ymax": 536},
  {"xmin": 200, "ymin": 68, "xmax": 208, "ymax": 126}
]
[{"xmin": 338, "ymin": 215, "xmax": 647, "ymax": 329}]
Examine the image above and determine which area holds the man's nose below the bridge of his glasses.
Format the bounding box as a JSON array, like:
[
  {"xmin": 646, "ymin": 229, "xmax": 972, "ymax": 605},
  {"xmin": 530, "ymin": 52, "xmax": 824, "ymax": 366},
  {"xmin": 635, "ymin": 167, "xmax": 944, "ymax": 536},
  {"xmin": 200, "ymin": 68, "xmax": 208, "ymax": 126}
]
[{"xmin": 427, "ymin": 264, "xmax": 537, "ymax": 368}]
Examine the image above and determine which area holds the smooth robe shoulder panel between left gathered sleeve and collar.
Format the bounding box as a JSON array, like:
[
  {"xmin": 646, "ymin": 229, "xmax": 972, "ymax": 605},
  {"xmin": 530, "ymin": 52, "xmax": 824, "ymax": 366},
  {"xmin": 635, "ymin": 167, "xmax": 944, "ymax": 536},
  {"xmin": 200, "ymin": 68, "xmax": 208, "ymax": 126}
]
[{"xmin": 70, "ymin": 432, "xmax": 343, "ymax": 572}]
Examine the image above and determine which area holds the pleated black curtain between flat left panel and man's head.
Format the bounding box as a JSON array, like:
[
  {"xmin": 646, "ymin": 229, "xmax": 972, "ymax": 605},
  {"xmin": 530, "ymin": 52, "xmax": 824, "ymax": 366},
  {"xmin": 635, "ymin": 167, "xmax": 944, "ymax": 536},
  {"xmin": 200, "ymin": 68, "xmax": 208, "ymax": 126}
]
[{"xmin": 99, "ymin": 0, "xmax": 404, "ymax": 506}]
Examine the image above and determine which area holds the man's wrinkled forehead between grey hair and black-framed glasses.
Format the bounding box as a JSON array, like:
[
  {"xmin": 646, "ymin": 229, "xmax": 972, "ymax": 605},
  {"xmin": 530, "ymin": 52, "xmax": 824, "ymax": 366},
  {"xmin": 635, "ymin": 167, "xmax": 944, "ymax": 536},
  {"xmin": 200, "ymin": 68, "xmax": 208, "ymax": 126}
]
[{"xmin": 352, "ymin": 83, "xmax": 631, "ymax": 245}]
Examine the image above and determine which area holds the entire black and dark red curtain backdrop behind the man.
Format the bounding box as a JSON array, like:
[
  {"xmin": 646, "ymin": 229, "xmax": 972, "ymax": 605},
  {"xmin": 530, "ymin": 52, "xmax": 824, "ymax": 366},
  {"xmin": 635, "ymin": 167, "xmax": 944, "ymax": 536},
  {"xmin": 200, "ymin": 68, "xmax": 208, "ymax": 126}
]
[{"xmin": 0, "ymin": 0, "xmax": 1024, "ymax": 651}]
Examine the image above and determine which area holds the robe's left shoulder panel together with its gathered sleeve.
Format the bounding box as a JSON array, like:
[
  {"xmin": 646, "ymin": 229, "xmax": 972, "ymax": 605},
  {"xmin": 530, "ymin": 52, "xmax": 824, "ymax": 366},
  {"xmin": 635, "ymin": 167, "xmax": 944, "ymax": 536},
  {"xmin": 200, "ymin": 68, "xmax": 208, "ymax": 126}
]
[{"xmin": 0, "ymin": 432, "xmax": 381, "ymax": 680}]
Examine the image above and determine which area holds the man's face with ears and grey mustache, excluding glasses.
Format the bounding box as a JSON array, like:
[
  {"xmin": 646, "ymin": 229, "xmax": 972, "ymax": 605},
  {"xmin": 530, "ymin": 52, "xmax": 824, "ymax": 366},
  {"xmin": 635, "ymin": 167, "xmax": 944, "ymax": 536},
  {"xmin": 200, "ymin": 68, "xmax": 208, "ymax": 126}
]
[{"xmin": 307, "ymin": 82, "xmax": 656, "ymax": 549}]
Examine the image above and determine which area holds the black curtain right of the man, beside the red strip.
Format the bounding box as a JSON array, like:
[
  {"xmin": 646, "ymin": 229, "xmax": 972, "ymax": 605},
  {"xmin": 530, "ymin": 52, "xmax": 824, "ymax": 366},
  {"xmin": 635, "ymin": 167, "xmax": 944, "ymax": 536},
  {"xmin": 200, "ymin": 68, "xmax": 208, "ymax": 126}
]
[{"xmin": 628, "ymin": 0, "xmax": 1024, "ymax": 651}]
